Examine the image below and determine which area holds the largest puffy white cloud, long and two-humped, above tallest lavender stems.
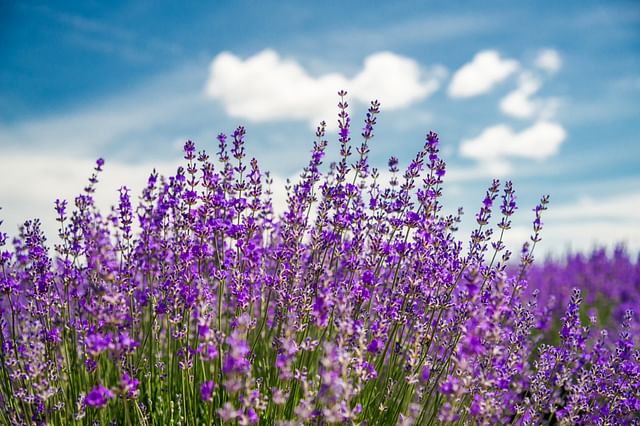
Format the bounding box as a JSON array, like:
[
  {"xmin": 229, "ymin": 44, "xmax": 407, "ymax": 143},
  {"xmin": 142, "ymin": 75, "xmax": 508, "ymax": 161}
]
[{"xmin": 205, "ymin": 49, "xmax": 446, "ymax": 126}]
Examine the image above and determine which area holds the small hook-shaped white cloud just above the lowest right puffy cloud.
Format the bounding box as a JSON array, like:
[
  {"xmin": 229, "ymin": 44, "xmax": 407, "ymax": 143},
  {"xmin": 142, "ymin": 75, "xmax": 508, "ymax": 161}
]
[{"xmin": 500, "ymin": 72, "xmax": 560, "ymax": 119}]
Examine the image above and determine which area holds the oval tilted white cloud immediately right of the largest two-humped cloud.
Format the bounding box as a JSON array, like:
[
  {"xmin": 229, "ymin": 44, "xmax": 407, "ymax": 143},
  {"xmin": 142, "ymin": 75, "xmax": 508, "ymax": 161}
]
[{"xmin": 448, "ymin": 50, "xmax": 520, "ymax": 98}]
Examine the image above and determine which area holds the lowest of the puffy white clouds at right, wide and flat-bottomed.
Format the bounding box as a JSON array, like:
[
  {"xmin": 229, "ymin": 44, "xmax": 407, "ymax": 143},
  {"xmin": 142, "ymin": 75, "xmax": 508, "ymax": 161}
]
[{"xmin": 460, "ymin": 121, "xmax": 567, "ymax": 167}]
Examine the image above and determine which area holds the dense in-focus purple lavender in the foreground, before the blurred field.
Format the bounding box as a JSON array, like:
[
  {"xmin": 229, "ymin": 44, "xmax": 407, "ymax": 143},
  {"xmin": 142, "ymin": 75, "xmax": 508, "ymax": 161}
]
[{"xmin": 0, "ymin": 92, "xmax": 640, "ymax": 425}]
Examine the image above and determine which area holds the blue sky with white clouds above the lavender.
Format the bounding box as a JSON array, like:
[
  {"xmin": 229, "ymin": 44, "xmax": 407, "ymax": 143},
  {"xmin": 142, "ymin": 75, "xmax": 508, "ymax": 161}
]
[{"xmin": 0, "ymin": 1, "xmax": 640, "ymax": 253}]
